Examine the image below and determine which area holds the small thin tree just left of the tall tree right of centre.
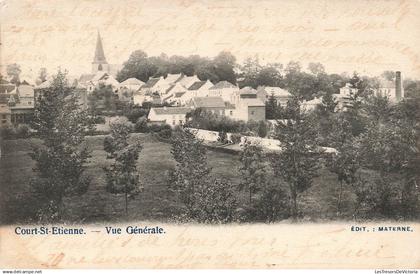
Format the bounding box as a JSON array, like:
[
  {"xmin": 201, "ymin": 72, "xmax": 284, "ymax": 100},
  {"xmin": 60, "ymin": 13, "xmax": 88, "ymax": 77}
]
[{"xmin": 238, "ymin": 141, "xmax": 267, "ymax": 204}]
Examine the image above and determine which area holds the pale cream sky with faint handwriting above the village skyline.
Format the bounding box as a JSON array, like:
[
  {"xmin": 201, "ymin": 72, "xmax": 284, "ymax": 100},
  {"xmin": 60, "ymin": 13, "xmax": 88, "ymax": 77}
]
[{"xmin": 0, "ymin": 0, "xmax": 420, "ymax": 81}]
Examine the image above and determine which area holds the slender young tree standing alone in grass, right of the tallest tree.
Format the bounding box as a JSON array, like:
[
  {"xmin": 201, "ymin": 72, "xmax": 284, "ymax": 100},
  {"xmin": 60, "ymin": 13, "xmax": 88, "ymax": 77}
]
[{"xmin": 104, "ymin": 120, "xmax": 142, "ymax": 214}]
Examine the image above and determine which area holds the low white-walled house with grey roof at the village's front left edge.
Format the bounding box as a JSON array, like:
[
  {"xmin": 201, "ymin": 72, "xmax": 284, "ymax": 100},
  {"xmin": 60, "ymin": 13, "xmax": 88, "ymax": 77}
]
[{"xmin": 147, "ymin": 107, "xmax": 192, "ymax": 127}]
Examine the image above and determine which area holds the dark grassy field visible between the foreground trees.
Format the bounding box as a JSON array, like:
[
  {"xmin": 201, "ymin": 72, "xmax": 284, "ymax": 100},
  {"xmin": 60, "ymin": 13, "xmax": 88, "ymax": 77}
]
[{"xmin": 0, "ymin": 134, "xmax": 354, "ymax": 224}]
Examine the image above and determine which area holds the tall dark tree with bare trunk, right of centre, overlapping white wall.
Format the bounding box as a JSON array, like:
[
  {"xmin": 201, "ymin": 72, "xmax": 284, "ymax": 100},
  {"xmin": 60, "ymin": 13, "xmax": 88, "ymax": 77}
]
[{"xmin": 271, "ymin": 96, "xmax": 320, "ymax": 219}]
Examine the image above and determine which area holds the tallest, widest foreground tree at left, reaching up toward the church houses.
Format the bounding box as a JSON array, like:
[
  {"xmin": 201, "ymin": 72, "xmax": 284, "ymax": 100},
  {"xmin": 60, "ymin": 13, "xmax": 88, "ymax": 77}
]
[{"xmin": 30, "ymin": 71, "xmax": 93, "ymax": 221}]
